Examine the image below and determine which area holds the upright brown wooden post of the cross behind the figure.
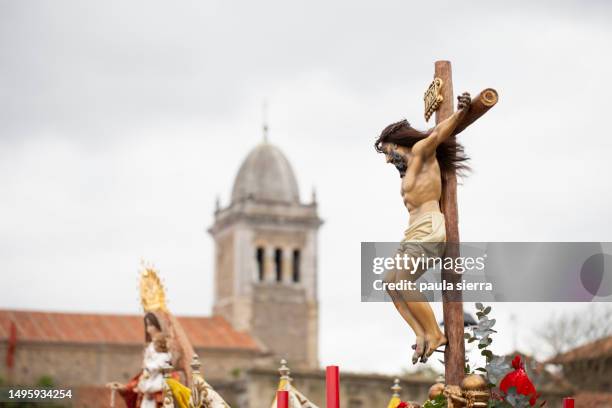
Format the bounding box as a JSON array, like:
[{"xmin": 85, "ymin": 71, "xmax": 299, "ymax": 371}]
[{"xmin": 434, "ymin": 61, "xmax": 466, "ymax": 385}]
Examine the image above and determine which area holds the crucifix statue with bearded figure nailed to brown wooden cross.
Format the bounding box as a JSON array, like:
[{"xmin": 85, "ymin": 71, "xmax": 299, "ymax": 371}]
[{"xmin": 375, "ymin": 61, "xmax": 497, "ymax": 385}]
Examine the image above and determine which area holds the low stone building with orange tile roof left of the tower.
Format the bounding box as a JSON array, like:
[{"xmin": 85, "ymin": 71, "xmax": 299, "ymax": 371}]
[{"xmin": 0, "ymin": 310, "xmax": 266, "ymax": 387}]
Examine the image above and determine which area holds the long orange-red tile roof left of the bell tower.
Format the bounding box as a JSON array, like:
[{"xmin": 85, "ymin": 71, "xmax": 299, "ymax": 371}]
[{"xmin": 0, "ymin": 310, "xmax": 261, "ymax": 351}]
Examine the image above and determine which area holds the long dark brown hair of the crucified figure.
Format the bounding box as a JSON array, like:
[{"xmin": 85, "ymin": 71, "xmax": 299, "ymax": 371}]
[{"xmin": 374, "ymin": 119, "xmax": 470, "ymax": 176}]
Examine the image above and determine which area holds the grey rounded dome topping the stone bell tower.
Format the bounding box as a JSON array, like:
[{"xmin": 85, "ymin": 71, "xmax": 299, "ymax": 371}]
[{"xmin": 232, "ymin": 142, "xmax": 300, "ymax": 204}]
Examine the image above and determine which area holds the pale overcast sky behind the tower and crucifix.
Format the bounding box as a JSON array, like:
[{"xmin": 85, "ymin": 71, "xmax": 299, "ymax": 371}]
[{"xmin": 0, "ymin": 0, "xmax": 612, "ymax": 373}]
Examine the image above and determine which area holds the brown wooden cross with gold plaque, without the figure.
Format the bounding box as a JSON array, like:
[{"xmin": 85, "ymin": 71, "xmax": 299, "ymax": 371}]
[{"xmin": 425, "ymin": 61, "xmax": 498, "ymax": 385}]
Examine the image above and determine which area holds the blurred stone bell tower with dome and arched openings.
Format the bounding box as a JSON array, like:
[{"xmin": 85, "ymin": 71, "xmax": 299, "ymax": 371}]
[{"xmin": 209, "ymin": 140, "xmax": 322, "ymax": 368}]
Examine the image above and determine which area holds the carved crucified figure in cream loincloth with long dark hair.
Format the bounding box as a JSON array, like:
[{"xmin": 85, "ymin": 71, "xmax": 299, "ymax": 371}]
[{"xmin": 375, "ymin": 93, "xmax": 471, "ymax": 364}]
